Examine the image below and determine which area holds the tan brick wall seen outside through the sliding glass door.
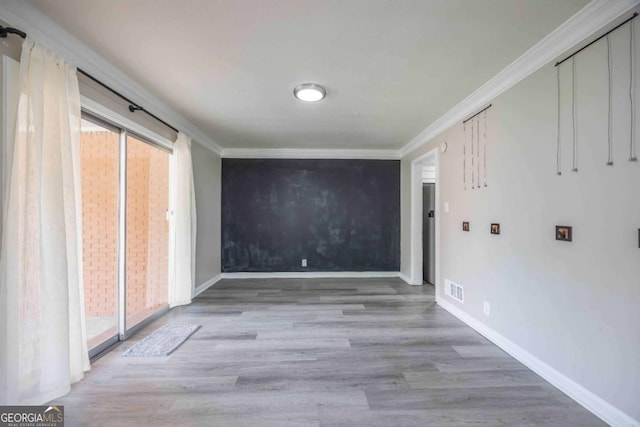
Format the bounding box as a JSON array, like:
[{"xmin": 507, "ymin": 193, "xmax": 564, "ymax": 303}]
[{"xmin": 81, "ymin": 131, "xmax": 169, "ymax": 317}]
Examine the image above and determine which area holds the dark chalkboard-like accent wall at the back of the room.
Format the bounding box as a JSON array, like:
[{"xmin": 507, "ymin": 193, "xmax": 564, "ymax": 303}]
[{"xmin": 222, "ymin": 159, "xmax": 400, "ymax": 272}]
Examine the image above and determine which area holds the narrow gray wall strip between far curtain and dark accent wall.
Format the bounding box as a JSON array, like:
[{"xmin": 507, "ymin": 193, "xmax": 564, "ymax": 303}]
[{"xmin": 191, "ymin": 143, "xmax": 222, "ymax": 288}]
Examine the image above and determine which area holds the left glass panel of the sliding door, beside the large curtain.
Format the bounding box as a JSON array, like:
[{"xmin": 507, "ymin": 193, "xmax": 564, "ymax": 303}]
[{"xmin": 80, "ymin": 119, "xmax": 119, "ymax": 350}]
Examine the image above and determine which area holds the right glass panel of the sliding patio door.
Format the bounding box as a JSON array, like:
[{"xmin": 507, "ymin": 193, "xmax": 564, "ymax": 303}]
[{"xmin": 125, "ymin": 135, "xmax": 170, "ymax": 330}]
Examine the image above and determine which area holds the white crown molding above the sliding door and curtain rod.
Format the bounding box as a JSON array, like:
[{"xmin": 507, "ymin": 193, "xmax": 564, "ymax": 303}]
[{"xmin": 0, "ymin": 1, "xmax": 222, "ymax": 154}]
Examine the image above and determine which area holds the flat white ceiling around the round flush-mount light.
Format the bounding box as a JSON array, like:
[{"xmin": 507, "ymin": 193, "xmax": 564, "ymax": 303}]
[{"xmin": 29, "ymin": 0, "xmax": 588, "ymax": 149}]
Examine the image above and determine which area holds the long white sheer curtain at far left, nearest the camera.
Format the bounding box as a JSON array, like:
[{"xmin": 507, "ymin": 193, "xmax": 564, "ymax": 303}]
[{"xmin": 0, "ymin": 38, "xmax": 90, "ymax": 405}]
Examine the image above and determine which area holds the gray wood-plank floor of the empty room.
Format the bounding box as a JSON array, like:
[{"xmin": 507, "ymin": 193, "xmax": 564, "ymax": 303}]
[{"xmin": 55, "ymin": 279, "xmax": 604, "ymax": 427}]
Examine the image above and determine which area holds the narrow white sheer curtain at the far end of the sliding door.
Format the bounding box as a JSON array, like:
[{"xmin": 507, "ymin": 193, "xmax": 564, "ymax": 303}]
[{"xmin": 169, "ymin": 132, "xmax": 196, "ymax": 307}]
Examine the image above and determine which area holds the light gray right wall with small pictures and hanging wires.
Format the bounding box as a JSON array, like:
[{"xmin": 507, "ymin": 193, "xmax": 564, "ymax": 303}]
[{"xmin": 401, "ymin": 15, "xmax": 640, "ymax": 423}]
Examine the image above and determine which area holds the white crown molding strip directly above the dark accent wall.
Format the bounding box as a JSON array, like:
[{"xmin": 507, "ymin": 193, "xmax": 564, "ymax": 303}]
[{"xmin": 221, "ymin": 148, "xmax": 400, "ymax": 160}]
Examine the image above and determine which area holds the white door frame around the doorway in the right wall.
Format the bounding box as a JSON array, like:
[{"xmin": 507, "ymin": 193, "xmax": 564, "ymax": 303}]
[{"xmin": 410, "ymin": 148, "xmax": 441, "ymax": 297}]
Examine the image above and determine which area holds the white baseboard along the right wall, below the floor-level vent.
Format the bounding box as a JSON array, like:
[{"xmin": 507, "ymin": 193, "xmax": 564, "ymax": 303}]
[{"xmin": 436, "ymin": 298, "xmax": 640, "ymax": 427}]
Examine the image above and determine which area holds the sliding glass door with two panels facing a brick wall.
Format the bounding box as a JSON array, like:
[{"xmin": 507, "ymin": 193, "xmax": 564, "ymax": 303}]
[{"xmin": 81, "ymin": 116, "xmax": 171, "ymax": 356}]
